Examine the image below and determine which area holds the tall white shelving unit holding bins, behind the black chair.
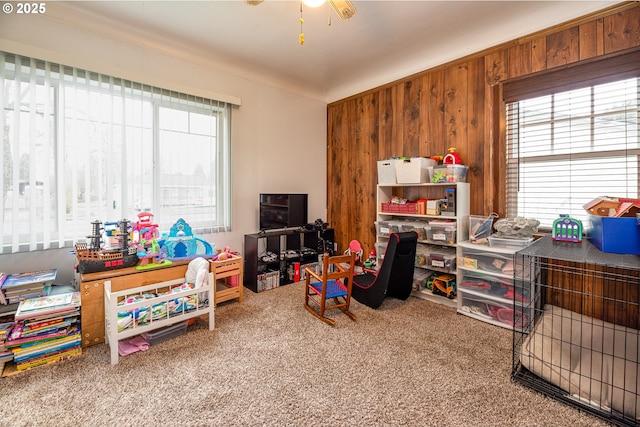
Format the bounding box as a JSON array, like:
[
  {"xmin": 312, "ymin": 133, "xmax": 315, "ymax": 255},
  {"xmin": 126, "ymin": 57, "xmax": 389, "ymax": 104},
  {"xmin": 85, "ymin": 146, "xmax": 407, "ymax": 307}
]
[{"xmin": 376, "ymin": 182, "xmax": 469, "ymax": 307}]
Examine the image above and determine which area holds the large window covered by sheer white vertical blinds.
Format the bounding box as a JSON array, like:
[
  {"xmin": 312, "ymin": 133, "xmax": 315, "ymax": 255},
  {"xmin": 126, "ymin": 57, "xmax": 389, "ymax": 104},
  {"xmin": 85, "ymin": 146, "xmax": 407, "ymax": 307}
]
[{"xmin": 0, "ymin": 52, "xmax": 231, "ymax": 253}]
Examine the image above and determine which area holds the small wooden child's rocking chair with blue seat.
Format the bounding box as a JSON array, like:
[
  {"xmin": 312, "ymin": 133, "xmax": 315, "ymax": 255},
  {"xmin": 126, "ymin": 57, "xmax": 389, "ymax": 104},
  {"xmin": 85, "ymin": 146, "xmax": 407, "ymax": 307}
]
[{"xmin": 304, "ymin": 253, "xmax": 356, "ymax": 326}]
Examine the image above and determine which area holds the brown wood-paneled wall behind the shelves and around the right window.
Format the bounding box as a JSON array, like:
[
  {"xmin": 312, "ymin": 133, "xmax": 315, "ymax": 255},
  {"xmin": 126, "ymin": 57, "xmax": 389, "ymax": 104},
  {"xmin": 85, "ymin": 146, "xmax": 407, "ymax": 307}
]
[{"xmin": 327, "ymin": 2, "xmax": 640, "ymax": 257}]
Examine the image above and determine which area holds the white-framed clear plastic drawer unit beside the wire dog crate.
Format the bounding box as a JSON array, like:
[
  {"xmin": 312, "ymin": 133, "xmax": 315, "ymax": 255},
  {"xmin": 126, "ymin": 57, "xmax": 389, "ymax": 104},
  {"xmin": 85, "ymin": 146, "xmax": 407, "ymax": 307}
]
[{"xmin": 457, "ymin": 241, "xmax": 533, "ymax": 331}]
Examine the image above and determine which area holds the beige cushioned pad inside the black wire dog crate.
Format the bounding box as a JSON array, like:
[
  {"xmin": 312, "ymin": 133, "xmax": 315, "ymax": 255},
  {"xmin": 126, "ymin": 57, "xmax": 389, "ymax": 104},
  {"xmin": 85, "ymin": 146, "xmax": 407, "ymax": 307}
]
[{"xmin": 520, "ymin": 305, "xmax": 640, "ymax": 420}]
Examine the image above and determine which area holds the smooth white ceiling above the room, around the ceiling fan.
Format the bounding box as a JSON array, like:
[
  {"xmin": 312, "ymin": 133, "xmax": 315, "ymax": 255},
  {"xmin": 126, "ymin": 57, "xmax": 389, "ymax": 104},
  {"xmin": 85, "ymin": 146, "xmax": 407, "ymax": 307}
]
[{"xmin": 55, "ymin": 0, "xmax": 620, "ymax": 102}]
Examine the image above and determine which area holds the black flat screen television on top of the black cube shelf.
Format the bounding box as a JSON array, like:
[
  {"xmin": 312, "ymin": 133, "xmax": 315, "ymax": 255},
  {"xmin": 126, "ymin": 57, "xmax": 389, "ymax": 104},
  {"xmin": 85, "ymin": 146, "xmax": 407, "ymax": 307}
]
[{"xmin": 260, "ymin": 193, "xmax": 308, "ymax": 230}]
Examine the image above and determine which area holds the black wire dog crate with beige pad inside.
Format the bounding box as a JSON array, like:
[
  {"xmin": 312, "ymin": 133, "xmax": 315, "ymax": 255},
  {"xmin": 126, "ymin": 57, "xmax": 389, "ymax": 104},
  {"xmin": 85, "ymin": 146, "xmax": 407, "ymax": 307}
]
[{"xmin": 511, "ymin": 236, "xmax": 640, "ymax": 426}]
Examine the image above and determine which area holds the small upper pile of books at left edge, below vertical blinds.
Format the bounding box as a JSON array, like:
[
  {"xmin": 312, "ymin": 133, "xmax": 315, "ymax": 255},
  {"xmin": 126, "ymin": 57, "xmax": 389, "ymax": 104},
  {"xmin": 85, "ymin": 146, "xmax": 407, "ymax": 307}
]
[{"xmin": 0, "ymin": 268, "xmax": 58, "ymax": 304}]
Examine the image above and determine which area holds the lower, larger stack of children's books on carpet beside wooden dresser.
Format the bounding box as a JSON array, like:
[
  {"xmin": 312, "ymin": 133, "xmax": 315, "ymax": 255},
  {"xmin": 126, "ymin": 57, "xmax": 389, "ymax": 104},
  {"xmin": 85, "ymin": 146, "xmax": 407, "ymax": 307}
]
[{"xmin": 3, "ymin": 292, "xmax": 82, "ymax": 376}]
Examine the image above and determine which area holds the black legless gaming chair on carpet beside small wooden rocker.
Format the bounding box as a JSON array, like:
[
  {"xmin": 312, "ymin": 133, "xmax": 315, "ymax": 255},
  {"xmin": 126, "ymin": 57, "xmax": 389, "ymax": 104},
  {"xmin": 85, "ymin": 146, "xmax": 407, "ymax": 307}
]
[{"xmin": 352, "ymin": 231, "xmax": 418, "ymax": 308}]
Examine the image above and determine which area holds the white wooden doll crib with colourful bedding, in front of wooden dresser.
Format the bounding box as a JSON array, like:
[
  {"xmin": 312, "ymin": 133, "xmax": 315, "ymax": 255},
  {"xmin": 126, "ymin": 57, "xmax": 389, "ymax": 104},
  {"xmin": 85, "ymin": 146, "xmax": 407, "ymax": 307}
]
[{"xmin": 104, "ymin": 273, "xmax": 215, "ymax": 365}]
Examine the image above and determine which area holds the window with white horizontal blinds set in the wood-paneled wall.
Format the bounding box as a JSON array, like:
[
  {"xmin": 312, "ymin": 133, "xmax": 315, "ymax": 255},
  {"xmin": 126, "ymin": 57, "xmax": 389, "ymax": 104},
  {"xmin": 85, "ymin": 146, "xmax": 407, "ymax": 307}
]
[{"xmin": 503, "ymin": 50, "xmax": 640, "ymax": 231}]
